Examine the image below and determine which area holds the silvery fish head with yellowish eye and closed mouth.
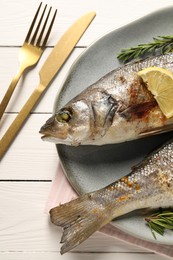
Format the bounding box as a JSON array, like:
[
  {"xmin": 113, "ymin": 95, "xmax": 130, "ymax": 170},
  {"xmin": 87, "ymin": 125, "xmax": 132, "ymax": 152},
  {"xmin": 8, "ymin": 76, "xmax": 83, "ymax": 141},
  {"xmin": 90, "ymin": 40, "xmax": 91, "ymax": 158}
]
[{"xmin": 39, "ymin": 100, "xmax": 90, "ymax": 146}]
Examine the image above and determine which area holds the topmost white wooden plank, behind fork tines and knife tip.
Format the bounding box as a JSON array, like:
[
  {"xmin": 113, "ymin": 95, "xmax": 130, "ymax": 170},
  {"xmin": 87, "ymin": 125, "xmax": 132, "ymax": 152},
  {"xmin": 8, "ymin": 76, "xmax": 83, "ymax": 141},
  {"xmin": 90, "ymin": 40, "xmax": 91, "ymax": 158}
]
[{"xmin": 0, "ymin": 0, "xmax": 172, "ymax": 46}]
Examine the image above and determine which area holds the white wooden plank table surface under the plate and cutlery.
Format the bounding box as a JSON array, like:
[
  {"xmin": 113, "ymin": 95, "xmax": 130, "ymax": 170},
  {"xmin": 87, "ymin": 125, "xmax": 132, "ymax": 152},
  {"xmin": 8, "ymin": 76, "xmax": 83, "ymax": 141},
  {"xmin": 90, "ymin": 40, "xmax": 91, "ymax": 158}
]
[{"xmin": 0, "ymin": 0, "xmax": 172, "ymax": 260}]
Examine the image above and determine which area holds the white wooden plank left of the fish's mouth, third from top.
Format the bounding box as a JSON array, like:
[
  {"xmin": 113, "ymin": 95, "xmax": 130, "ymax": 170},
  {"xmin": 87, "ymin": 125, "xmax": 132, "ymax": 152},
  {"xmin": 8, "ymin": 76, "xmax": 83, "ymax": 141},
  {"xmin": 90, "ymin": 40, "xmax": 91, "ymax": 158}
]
[{"xmin": 0, "ymin": 114, "xmax": 61, "ymax": 180}]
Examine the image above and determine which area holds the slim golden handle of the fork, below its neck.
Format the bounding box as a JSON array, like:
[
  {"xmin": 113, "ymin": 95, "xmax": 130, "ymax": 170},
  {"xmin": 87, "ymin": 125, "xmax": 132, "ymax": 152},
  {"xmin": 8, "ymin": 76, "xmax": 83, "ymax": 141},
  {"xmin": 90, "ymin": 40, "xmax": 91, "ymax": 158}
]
[{"xmin": 0, "ymin": 67, "xmax": 25, "ymax": 120}]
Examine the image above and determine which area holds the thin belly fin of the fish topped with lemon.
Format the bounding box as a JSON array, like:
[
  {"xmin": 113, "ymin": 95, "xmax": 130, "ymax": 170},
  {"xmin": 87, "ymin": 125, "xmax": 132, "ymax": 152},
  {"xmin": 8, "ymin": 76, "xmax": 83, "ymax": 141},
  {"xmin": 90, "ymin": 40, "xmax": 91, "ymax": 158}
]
[{"xmin": 139, "ymin": 123, "xmax": 173, "ymax": 137}]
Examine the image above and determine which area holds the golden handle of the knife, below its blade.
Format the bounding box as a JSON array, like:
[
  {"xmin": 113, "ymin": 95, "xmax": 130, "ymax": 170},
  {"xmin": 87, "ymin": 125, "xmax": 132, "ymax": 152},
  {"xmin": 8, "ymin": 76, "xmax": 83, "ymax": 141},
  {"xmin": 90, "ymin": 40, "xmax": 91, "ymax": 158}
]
[{"xmin": 0, "ymin": 83, "xmax": 44, "ymax": 159}]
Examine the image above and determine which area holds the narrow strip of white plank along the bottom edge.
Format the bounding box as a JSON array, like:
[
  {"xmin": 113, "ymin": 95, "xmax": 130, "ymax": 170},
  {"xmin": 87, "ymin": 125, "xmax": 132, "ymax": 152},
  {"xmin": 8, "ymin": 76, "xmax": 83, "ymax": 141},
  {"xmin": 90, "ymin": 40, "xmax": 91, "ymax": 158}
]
[{"xmin": 0, "ymin": 252, "xmax": 167, "ymax": 260}]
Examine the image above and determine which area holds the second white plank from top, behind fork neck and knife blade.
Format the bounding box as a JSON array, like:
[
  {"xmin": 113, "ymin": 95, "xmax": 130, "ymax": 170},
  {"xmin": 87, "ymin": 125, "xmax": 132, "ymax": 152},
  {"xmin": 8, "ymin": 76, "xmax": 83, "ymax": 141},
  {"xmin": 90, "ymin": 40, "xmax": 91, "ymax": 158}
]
[{"xmin": 0, "ymin": 47, "xmax": 85, "ymax": 114}]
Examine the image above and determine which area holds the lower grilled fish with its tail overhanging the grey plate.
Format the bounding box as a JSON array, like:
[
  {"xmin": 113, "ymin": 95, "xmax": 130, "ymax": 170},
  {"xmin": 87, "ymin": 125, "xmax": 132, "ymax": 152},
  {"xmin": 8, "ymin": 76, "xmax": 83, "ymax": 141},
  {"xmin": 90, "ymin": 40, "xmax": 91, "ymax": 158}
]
[{"xmin": 50, "ymin": 139, "xmax": 173, "ymax": 254}]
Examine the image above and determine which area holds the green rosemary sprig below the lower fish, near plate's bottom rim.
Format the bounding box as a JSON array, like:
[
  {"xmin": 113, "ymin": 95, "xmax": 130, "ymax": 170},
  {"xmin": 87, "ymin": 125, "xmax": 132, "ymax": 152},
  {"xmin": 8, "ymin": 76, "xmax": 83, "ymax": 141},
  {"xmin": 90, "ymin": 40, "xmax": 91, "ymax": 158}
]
[{"xmin": 145, "ymin": 211, "xmax": 173, "ymax": 239}]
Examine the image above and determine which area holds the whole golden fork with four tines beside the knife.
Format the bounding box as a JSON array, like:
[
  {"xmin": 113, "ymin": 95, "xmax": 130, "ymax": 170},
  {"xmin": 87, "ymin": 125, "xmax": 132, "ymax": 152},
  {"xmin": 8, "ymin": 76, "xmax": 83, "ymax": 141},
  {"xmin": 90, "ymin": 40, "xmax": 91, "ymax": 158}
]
[{"xmin": 0, "ymin": 3, "xmax": 57, "ymax": 119}]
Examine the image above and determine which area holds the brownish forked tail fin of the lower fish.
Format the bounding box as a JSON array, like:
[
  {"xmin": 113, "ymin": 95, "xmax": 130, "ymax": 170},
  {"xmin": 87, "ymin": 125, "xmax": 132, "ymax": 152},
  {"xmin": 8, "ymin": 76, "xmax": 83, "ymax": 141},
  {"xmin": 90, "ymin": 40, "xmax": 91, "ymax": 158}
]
[{"xmin": 50, "ymin": 194, "xmax": 110, "ymax": 254}]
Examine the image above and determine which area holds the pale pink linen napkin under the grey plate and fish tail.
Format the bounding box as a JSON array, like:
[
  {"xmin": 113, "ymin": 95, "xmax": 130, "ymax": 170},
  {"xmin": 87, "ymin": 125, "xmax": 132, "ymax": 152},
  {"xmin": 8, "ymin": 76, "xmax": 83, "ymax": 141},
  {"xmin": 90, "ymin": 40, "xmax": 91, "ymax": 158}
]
[{"xmin": 45, "ymin": 162, "xmax": 173, "ymax": 258}]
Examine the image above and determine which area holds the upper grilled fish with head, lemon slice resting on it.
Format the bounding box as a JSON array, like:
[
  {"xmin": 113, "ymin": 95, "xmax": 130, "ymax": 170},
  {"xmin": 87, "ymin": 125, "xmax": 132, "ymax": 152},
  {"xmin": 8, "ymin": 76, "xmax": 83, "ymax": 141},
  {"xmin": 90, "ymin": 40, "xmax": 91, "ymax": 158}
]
[{"xmin": 40, "ymin": 53, "xmax": 173, "ymax": 146}]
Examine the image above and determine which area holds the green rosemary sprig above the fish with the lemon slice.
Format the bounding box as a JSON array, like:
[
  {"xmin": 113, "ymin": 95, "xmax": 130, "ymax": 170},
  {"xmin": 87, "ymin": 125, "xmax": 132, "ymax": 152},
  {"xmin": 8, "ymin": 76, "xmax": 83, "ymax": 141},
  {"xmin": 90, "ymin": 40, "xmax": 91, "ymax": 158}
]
[{"xmin": 117, "ymin": 35, "xmax": 173, "ymax": 63}]
